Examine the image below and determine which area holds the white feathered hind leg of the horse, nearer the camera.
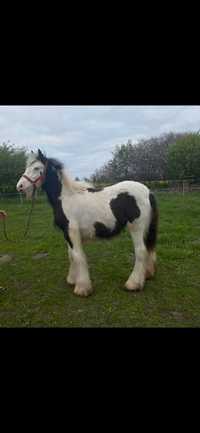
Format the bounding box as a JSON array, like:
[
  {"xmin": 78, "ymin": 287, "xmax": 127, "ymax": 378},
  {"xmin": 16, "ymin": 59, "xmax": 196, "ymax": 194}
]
[{"xmin": 125, "ymin": 224, "xmax": 148, "ymax": 290}]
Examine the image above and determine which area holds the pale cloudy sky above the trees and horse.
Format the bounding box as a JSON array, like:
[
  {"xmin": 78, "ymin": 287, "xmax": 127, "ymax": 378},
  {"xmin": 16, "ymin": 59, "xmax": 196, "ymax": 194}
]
[{"xmin": 0, "ymin": 105, "xmax": 200, "ymax": 179}]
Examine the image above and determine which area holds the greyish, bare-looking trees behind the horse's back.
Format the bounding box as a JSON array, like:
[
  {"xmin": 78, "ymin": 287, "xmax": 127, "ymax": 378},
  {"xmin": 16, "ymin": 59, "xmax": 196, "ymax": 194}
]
[{"xmin": 92, "ymin": 132, "xmax": 188, "ymax": 183}]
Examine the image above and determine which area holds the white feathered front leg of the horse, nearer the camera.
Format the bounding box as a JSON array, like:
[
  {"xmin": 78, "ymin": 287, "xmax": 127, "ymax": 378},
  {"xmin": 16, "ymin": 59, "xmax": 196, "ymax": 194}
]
[{"xmin": 69, "ymin": 225, "xmax": 92, "ymax": 296}]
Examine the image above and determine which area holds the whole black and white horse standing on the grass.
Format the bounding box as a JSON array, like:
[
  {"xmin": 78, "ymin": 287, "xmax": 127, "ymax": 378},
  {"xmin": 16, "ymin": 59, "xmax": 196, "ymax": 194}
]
[{"xmin": 17, "ymin": 150, "xmax": 158, "ymax": 296}]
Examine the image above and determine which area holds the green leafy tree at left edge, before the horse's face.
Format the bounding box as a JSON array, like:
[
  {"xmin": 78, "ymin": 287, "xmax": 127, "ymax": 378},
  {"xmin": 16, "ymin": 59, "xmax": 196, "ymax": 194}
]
[{"xmin": 0, "ymin": 143, "xmax": 26, "ymax": 193}]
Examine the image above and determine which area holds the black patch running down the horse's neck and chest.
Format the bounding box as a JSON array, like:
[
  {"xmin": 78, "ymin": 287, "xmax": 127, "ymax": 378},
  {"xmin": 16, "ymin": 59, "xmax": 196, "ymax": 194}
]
[{"xmin": 42, "ymin": 159, "xmax": 73, "ymax": 248}]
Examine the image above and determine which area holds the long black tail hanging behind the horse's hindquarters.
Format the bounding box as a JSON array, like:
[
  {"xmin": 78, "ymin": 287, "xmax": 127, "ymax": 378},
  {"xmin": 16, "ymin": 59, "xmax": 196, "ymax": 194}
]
[{"xmin": 144, "ymin": 192, "xmax": 159, "ymax": 251}]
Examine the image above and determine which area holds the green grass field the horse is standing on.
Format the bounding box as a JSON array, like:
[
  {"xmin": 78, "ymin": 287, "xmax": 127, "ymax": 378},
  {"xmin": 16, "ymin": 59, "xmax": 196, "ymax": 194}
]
[{"xmin": 0, "ymin": 193, "xmax": 200, "ymax": 327}]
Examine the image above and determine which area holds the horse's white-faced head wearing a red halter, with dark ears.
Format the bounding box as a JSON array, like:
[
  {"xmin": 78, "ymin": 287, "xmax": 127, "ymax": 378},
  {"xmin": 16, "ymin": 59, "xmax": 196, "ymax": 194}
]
[{"xmin": 16, "ymin": 150, "xmax": 48, "ymax": 198}]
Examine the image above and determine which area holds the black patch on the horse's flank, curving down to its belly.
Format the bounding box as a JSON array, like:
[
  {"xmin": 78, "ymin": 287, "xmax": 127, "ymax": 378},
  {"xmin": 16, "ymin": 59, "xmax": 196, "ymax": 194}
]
[{"xmin": 94, "ymin": 192, "xmax": 140, "ymax": 238}]
